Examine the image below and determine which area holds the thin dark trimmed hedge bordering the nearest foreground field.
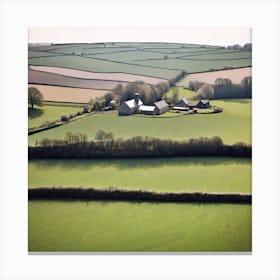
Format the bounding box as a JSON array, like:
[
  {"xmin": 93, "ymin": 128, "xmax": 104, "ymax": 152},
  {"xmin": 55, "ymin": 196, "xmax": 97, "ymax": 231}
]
[{"xmin": 28, "ymin": 187, "xmax": 252, "ymax": 204}]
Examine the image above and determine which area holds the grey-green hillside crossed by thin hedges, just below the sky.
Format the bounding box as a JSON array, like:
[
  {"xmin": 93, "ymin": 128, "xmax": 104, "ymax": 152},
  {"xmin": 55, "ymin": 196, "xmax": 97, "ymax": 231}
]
[{"xmin": 28, "ymin": 43, "xmax": 252, "ymax": 79}]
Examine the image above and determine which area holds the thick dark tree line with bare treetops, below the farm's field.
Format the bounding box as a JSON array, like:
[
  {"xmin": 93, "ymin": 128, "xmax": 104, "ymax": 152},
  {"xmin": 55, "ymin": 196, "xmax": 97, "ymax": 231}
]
[{"xmin": 28, "ymin": 130, "xmax": 251, "ymax": 159}]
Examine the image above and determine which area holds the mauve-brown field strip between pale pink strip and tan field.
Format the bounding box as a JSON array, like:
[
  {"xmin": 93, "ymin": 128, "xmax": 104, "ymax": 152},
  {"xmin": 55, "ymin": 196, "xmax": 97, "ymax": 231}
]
[{"xmin": 28, "ymin": 70, "xmax": 126, "ymax": 90}]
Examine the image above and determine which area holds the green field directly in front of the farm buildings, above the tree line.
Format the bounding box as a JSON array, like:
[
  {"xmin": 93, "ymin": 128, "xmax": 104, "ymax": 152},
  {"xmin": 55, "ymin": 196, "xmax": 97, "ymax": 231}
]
[{"xmin": 28, "ymin": 99, "xmax": 251, "ymax": 146}]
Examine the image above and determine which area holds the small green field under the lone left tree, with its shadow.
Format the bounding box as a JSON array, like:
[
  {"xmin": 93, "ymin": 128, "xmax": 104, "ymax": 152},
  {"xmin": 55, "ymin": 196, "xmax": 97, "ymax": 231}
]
[{"xmin": 28, "ymin": 105, "xmax": 82, "ymax": 128}]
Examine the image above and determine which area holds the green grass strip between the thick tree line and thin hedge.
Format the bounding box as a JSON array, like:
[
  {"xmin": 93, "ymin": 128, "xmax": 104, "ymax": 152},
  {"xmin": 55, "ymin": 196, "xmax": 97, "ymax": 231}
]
[{"xmin": 28, "ymin": 157, "xmax": 251, "ymax": 193}]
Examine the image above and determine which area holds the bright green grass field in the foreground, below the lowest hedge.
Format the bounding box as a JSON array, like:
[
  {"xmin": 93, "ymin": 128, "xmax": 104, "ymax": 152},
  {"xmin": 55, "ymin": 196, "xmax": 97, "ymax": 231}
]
[{"xmin": 28, "ymin": 201, "xmax": 252, "ymax": 252}]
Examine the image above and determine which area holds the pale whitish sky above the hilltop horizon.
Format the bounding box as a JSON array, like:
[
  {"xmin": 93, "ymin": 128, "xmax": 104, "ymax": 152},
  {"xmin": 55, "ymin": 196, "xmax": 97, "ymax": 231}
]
[{"xmin": 28, "ymin": 27, "xmax": 251, "ymax": 46}]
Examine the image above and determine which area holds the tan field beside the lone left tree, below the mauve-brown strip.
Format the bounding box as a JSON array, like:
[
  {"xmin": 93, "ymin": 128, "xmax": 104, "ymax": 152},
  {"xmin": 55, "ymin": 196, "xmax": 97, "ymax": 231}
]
[{"xmin": 28, "ymin": 84, "xmax": 109, "ymax": 103}]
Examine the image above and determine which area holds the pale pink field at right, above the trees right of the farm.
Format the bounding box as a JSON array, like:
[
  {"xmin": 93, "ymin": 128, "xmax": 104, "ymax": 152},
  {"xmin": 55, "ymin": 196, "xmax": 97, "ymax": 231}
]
[{"xmin": 177, "ymin": 67, "xmax": 252, "ymax": 87}]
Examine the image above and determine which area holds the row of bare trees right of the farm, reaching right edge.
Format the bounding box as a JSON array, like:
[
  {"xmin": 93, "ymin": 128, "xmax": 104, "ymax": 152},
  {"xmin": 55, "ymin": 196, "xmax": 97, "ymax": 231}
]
[{"xmin": 190, "ymin": 76, "xmax": 252, "ymax": 100}]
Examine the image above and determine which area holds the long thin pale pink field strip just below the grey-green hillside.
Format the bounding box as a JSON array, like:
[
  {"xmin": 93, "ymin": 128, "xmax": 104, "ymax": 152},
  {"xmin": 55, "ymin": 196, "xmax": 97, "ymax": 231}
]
[{"xmin": 30, "ymin": 66, "xmax": 167, "ymax": 84}]
